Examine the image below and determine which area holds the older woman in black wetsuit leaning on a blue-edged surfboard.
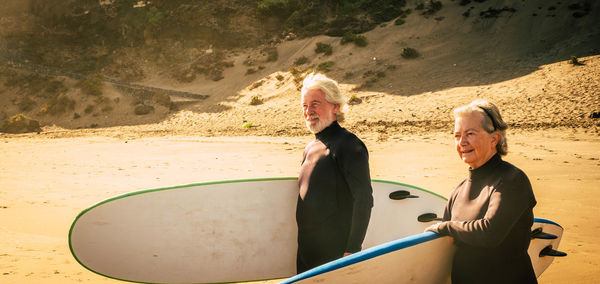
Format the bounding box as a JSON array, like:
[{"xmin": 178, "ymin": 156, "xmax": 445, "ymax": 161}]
[{"xmin": 426, "ymin": 100, "xmax": 537, "ymax": 284}]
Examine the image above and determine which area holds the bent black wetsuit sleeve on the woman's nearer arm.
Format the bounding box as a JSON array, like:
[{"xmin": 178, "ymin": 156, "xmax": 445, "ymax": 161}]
[{"xmin": 438, "ymin": 171, "xmax": 535, "ymax": 247}]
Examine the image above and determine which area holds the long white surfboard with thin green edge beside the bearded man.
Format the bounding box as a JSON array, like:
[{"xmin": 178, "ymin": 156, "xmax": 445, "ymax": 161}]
[{"xmin": 69, "ymin": 178, "xmax": 446, "ymax": 283}]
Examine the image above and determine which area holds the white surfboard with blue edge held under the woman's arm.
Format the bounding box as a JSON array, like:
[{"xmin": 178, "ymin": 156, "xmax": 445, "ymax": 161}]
[{"xmin": 281, "ymin": 218, "xmax": 562, "ymax": 284}]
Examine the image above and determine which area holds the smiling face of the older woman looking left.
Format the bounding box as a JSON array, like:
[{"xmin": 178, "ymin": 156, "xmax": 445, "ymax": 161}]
[{"xmin": 454, "ymin": 112, "xmax": 500, "ymax": 169}]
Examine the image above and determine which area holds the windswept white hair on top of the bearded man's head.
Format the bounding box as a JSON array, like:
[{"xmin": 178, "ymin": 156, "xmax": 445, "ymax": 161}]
[{"xmin": 300, "ymin": 73, "xmax": 346, "ymax": 122}]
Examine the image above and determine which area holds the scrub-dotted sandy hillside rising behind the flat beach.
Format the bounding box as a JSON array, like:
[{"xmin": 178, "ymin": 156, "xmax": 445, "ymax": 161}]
[{"xmin": 0, "ymin": 0, "xmax": 600, "ymax": 135}]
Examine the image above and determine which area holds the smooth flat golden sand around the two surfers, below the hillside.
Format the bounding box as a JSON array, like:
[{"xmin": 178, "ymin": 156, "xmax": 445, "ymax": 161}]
[{"xmin": 0, "ymin": 129, "xmax": 600, "ymax": 283}]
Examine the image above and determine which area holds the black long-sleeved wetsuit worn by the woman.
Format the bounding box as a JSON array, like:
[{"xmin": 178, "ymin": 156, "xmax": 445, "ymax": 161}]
[{"xmin": 438, "ymin": 155, "xmax": 537, "ymax": 284}]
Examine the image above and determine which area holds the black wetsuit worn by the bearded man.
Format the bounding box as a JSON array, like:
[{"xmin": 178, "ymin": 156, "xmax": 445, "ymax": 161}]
[{"xmin": 296, "ymin": 121, "xmax": 373, "ymax": 273}]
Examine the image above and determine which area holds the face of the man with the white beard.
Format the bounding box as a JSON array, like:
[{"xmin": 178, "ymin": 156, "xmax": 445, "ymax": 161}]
[{"xmin": 301, "ymin": 89, "xmax": 340, "ymax": 133}]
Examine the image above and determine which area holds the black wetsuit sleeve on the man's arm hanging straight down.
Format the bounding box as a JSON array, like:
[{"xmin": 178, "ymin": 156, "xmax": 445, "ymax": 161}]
[{"xmin": 340, "ymin": 141, "xmax": 373, "ymax": 253}]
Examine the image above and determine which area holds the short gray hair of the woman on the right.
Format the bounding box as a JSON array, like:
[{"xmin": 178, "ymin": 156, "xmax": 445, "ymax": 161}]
[{"xmin": 454, "ymin": 99, "xmax": 508, "ymax": 156}]
